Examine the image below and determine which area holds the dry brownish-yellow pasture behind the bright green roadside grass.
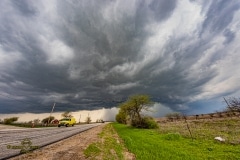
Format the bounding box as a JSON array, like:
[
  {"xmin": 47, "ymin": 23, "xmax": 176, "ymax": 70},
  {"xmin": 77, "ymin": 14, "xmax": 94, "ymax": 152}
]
[{"xmin": 159, "ymin": 117, "xmax": 240, "ymax": 145}]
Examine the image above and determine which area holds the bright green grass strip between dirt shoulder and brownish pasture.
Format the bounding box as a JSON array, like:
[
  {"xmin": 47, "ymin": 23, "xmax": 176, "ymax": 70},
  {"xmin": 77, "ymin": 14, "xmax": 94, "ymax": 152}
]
[{"xmin": 112, "ymin": 123, "xmax": 240, "ymax": 160}]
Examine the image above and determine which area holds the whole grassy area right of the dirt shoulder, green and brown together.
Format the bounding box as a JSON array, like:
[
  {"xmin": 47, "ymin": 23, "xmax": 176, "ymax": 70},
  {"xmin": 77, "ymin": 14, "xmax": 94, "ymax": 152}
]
[{"xmin": 111, "ymin": 119, "xmax": 240, "ymax": 160}]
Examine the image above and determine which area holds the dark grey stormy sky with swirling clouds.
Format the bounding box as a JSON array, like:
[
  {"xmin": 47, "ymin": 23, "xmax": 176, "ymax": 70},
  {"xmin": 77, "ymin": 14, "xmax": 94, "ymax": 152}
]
[{"xmin": 0, "ymin": 0, "xmax": 240, "ymax": 113}]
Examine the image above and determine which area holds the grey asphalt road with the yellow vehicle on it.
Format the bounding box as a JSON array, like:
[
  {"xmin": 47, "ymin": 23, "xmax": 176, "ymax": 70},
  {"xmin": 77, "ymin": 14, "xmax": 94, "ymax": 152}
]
[{"xmin": 0, "ymin": 123, "xmax": 101, "ymax": 159}]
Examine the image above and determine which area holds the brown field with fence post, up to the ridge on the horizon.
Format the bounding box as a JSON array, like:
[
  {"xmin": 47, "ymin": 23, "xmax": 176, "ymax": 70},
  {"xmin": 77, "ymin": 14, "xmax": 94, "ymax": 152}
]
[{"xmin": 156, "ymin": 112, "xmax": 240, "ymax": 145}]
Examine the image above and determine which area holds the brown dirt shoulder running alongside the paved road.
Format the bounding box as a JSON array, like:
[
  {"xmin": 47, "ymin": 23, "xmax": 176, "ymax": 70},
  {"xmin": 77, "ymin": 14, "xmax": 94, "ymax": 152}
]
[{"xmin": 8, "ymin": 124, "xmax": 106, "ymax": 160}]
